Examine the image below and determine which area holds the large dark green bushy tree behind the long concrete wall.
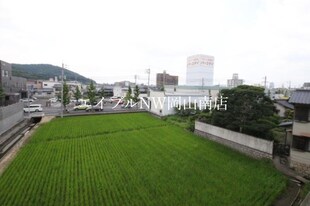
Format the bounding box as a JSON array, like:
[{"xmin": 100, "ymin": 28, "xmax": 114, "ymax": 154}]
[{"xmin": 211, "ymin": 85, "xmax": 278, "ymax": 139}]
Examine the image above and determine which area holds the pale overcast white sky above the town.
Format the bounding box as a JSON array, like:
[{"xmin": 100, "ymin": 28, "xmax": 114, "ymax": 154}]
[{"xmin": 0, "ymin": 0, "xmax": 310, "ymax": 87}]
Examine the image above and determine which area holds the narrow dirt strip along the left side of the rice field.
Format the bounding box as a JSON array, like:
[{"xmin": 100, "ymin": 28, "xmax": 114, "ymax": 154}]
[{"xmin": 0, "ymin": 116, "xmax": 55, "ymax": 175}]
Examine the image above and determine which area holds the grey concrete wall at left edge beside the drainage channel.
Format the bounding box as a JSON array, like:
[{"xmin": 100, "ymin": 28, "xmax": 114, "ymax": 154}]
[{"xmin": 0, "ymin": 102, "xmax": 24, "ymax": 135}]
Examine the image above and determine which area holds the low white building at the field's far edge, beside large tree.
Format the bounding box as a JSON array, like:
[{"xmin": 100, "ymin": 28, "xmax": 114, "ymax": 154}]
[{"xmin": 149, "ymin": 85, "xmax": 223, "ymax": 116}]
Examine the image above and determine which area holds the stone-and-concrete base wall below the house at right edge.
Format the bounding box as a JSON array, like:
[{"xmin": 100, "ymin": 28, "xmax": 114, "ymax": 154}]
[{"xmin": 290, "ymin": 149, "xmax": 310, "ymax": 178}]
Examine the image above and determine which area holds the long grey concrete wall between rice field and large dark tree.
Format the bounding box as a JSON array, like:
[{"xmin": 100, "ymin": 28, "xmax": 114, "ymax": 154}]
[{"xmin": 195, "ymin": 121, "xmax": 273, "ymax": 159}]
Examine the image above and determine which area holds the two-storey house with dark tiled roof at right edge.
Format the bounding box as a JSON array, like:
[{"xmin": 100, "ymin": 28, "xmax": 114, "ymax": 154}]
[{"xmin": 289, "ymin": 89, "xmax": 310, "ymax": 177}]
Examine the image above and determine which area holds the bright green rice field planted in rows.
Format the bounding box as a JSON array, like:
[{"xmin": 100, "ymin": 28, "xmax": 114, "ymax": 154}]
[{"xmin": 0, "ymin": 113, "xmax": 286, "ymax": 206}]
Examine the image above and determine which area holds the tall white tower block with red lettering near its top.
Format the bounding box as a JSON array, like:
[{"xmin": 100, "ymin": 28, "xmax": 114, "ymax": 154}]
[{"xmin": 186, "ymin": 54, "xmax": 214, "ymax": 86}]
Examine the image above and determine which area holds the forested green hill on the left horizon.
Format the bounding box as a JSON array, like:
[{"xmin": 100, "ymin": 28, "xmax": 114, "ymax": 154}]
[{"xmin": 12, "ymin": 64, "xmax": 95, "ymax": 84}]
